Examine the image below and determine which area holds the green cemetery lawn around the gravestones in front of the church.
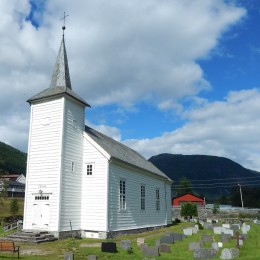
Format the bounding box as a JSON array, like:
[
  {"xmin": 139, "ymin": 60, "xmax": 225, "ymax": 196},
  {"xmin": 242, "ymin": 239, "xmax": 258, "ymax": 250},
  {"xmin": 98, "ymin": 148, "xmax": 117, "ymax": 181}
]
[{"xmin": 0, "ymin": 222, "xmax": 260, "ymax": 260}]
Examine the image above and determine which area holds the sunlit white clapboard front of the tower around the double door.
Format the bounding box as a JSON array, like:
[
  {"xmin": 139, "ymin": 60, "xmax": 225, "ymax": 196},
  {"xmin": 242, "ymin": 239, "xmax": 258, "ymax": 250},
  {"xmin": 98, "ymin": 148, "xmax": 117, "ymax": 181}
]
[{"xmin": 24, "ymin": 98, "xmax": 63, "ymax": 230}]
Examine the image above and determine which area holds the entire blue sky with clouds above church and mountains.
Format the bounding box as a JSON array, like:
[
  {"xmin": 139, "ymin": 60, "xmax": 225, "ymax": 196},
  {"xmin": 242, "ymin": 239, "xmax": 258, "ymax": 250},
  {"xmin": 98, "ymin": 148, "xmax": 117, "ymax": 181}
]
[{"xmin": 0, "ymin": 0, "xmax": 260, "ymax": 171}]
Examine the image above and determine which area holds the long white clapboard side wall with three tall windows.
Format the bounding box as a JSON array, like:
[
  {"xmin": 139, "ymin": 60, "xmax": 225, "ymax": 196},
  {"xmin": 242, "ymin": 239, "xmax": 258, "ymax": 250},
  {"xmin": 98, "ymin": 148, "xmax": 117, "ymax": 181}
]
[{"xmin": 109, "ymin": 161, "xmax": 169, "ymax": 231}]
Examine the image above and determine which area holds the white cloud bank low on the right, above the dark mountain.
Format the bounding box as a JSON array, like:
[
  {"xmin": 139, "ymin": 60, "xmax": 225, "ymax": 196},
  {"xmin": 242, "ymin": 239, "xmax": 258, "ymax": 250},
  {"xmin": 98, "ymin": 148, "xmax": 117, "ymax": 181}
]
[{"xmin": 124, "ymin": 89, "xmax": 260, "ymax": 171}]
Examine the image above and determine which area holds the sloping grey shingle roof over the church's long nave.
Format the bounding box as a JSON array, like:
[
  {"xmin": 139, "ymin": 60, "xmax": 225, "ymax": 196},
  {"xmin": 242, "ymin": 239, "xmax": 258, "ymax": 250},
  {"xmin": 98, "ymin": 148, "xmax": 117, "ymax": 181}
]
[{"xmin": 85, "ymin": 126, "xmax": 172, "ymax": 181}]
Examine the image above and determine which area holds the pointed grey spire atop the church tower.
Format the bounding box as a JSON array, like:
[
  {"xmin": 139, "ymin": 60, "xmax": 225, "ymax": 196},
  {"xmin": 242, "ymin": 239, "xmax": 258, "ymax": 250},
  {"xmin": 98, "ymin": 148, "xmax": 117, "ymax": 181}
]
[{"xmin": 50, "ymin": 35, "xmax": 71, "ymax": 89}]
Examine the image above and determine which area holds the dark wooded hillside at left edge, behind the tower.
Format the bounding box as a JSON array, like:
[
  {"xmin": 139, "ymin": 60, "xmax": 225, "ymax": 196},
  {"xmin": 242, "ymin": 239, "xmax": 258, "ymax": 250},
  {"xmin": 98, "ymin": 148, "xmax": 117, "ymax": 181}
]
[{"xmin": 0, "ymin": 142, "xmax": 27, "ymax": 174}]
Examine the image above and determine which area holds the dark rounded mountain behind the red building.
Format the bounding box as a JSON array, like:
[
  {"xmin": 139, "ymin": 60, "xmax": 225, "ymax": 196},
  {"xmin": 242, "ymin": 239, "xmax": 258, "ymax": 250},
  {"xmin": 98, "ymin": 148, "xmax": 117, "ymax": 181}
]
[{"xmin": 149, "ymin": 154, "xmax": 260, "ymax": 198}]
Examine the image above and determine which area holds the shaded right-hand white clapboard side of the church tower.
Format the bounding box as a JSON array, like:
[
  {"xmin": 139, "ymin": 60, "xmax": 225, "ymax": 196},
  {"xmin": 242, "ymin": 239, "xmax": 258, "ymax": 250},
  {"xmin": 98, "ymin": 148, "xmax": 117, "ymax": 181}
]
[{"xmin": 60, "ymin": 99, "xmax": 84, "ymax": 231}]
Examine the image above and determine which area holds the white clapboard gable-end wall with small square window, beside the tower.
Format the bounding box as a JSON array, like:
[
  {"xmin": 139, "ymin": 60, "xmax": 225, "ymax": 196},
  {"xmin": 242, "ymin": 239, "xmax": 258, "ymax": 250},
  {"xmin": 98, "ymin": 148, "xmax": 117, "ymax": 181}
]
[{"xmin": 82, "ymin": 135, "xmax": 108, "ymax": 231}]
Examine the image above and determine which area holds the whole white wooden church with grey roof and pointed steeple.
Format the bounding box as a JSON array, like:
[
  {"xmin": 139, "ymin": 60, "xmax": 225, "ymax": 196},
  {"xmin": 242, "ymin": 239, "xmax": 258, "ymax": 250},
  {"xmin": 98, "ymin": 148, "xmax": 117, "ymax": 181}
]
[{"xmin": 23, "ymin": 30, "xmax": 172, "ymax": 238}]
